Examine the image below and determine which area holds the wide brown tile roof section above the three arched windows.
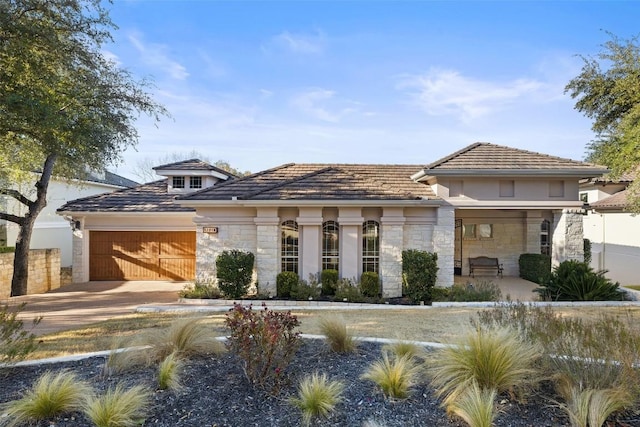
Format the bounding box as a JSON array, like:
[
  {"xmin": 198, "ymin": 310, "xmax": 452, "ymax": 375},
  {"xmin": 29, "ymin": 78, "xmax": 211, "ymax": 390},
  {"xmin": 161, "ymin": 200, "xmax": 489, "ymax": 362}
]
[{"xmin": 180, "ymin": 163, "xmax": 435, "ymax": 201}]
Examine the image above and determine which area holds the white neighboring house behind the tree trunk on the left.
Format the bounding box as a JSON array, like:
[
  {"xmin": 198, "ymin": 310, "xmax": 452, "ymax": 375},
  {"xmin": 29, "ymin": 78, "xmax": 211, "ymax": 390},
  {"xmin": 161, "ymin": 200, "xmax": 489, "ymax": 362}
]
[{"xmin": 0, "ymin": 172, "xmax": 139, "ymax": 267}]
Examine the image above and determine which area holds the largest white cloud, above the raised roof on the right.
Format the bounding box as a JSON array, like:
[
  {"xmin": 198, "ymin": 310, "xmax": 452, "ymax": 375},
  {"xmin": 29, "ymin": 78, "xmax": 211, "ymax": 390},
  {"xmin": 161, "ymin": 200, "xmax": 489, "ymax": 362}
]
[{"xmin": 399, "ymin": 69, "xmax": 545, "ymax": 122}]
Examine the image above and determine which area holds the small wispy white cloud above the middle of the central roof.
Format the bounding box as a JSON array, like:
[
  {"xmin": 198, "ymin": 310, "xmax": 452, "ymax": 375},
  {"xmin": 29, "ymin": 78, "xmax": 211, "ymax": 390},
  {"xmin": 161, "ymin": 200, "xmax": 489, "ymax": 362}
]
[{"xmin": 291, "ymin": 88, "xmax": 358, "ymax": 123}]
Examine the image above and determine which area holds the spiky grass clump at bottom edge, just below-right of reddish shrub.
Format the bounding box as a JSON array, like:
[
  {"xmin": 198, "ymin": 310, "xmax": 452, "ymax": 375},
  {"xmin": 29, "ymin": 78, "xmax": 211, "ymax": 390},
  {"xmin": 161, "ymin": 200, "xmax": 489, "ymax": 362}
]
[{"xmin": 289, "ymin": 372, "xmax": 344, "ymax": 426}]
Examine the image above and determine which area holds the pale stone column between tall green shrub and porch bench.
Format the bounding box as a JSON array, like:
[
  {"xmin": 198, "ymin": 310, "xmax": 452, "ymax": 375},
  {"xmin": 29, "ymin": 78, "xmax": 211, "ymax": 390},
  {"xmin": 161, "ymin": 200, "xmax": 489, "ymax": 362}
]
[{"xmin": 433, "ymin": 206, "xmax": 455, "ymax": 287}]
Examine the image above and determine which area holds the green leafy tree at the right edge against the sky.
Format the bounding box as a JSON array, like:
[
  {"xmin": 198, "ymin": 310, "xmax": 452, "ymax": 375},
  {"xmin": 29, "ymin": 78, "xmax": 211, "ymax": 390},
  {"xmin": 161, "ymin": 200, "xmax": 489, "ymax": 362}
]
[{"xmin": 565, "ymin": 33, "xmax": 640, "ymax": 212}]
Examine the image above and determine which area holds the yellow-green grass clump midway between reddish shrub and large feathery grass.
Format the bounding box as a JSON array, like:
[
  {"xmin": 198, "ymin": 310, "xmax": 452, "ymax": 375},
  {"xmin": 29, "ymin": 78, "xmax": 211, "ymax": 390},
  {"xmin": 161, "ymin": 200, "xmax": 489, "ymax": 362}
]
[{"xmin": 362, "ymin": 352, "xmax": 420, "ymax": 399}]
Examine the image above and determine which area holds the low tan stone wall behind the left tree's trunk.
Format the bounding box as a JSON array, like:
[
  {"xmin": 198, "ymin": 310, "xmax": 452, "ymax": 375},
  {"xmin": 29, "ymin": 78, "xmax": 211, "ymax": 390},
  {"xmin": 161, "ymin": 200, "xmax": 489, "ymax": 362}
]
[{"xmin": 0, "ymin": 248, "xmax": 60, "ymax": 299}]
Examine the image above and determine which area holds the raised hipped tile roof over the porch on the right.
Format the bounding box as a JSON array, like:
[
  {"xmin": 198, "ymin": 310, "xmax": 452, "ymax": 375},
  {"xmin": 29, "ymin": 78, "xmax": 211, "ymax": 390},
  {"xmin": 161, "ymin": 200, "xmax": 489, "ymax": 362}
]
[{"xmin": 424, "ymin": 142, "xmax": 605, "ymax": 171}]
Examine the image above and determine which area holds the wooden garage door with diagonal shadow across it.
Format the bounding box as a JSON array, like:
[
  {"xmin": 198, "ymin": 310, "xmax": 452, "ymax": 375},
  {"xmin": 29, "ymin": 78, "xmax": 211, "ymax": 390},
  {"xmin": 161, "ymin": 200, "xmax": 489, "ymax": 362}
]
[{"xmin": 89, "ymin": 231, "xmax": 196, "ymax": 281}]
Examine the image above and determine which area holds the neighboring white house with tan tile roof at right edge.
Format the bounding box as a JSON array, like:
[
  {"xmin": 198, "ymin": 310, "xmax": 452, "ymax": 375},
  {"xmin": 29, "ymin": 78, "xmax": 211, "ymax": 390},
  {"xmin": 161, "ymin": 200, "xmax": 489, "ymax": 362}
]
[{"xmin": 580, "ymin": 174, "xmax": 640, "ymax": 285}]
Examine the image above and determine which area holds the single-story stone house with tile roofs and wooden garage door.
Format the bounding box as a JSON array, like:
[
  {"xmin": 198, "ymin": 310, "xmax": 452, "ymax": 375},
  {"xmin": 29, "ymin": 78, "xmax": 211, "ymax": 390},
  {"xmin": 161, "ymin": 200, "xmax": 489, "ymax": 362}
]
[{"xmin": 58, "ymin": 143, "xmax": 607, "ymax": 297}]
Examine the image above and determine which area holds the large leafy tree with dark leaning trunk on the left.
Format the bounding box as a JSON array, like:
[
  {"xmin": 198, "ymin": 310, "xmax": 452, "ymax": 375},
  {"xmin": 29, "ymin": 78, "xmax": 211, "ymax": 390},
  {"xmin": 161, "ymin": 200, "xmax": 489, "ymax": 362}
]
[{"xmin": 0, "ymin": 0, "xmax": 167, "ymax": 296}]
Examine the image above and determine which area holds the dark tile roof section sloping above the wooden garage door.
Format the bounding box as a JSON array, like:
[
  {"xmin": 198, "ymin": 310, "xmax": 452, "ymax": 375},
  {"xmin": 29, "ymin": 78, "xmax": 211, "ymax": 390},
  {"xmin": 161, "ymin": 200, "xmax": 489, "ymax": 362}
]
[{"xmin": 58, "ymin": 179, "xmax": 194, "ymax": 212}]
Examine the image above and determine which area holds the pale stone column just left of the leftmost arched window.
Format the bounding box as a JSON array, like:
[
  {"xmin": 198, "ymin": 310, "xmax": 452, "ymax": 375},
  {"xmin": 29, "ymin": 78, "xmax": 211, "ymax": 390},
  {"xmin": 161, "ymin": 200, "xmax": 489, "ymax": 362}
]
[{"xmin": 254, "ymin": 207, "xmax": 280, "ymax": 295}]
